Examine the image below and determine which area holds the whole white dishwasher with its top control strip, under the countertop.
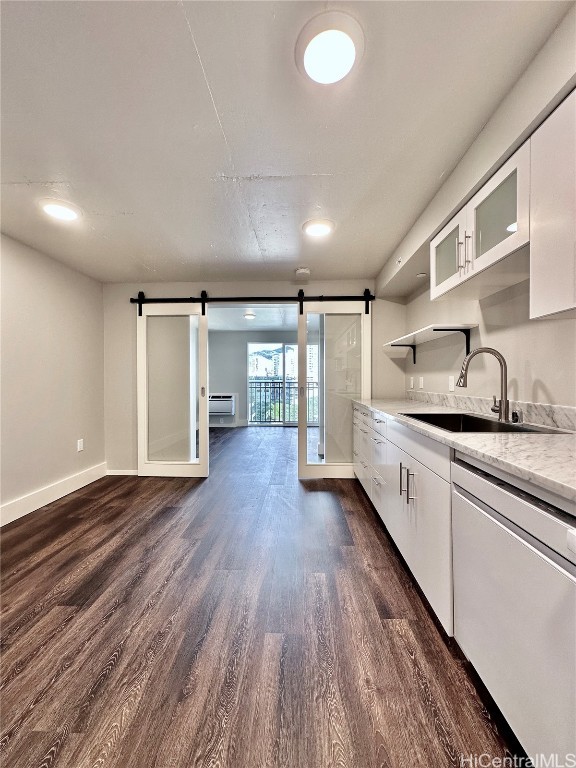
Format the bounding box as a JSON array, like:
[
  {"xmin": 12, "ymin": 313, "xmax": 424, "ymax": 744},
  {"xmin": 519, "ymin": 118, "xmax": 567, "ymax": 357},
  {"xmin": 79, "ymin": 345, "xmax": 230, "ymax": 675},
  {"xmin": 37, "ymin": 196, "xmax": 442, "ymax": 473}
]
[{"xmin": 452, "ymin": 461, "xmax": 576, "ymax": 765}]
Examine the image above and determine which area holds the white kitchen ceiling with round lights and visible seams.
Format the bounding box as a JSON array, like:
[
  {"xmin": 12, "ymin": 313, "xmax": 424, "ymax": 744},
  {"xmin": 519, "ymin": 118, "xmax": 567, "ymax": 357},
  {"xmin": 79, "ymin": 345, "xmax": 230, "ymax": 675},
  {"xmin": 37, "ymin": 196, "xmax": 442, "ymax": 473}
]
[{"xmin": 1, "ymin": 0, "xmax": 570, "ymax": 282}]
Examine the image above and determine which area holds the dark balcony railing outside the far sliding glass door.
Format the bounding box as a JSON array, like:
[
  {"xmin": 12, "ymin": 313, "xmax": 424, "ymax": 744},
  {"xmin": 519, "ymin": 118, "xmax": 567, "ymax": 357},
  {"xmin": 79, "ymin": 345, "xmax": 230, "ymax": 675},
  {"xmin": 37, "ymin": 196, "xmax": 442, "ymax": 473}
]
[{"xmin": 248, "ymin": 380, "xmax": 318, "ymax": 425}]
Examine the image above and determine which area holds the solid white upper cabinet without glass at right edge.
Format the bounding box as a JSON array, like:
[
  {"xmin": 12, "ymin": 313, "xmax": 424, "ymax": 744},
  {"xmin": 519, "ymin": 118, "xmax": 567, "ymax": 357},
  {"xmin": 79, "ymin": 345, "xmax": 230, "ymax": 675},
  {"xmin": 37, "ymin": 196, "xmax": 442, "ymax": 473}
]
[{"xmin": 530, "ymin": 91, "xmax": 576, "ymax": 318}]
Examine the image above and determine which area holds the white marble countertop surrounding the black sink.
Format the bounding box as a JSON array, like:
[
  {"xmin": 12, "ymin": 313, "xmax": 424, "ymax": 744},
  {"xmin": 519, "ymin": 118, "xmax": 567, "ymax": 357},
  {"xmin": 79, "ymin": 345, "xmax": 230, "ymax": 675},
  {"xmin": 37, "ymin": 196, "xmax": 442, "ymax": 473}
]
[{"xmin": 355, "ymin": 400, "xmax": 576, "ymax": 501}]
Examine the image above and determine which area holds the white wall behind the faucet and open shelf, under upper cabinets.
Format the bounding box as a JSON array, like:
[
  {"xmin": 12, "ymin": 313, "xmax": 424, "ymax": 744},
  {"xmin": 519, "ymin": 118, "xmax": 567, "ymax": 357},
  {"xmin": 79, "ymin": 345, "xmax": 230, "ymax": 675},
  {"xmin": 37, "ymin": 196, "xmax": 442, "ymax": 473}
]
[{"xmin": 405, "ymin": 281, "xmax": 576, "ymax": 406}]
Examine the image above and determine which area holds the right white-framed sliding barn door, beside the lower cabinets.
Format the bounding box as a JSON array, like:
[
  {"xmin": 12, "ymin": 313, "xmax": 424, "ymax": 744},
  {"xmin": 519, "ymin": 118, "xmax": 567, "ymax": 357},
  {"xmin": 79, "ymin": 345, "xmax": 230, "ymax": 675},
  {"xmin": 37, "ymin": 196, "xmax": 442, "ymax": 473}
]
[{"xmin": 298, "ymin": 301, "xmax": 371, "ymax": 478}]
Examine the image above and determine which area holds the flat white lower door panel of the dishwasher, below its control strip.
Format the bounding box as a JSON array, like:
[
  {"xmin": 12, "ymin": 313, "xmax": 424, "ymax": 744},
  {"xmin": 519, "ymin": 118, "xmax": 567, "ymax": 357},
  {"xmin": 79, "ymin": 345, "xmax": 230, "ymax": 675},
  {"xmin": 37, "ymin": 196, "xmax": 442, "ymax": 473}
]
[{"xmin": 452, "ymin": 490, "xmax": 576, "ymax": 764}]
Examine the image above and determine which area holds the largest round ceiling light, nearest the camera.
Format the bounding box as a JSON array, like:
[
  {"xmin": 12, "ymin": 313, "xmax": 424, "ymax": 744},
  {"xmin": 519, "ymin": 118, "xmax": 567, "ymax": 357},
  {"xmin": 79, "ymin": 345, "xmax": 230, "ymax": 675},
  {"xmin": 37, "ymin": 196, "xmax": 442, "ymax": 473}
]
[{"xmin": 295, "ymin": 11, "xmax": 364, "ymax": 85}]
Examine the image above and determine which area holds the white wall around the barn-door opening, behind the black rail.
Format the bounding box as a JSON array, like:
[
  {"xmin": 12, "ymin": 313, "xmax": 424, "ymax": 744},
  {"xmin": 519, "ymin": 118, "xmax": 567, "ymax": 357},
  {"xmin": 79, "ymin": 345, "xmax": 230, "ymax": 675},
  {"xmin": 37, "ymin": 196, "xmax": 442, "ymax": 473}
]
[{"xmin": 104, "ymin": 280, "xmax": 405, "ymax": 472}]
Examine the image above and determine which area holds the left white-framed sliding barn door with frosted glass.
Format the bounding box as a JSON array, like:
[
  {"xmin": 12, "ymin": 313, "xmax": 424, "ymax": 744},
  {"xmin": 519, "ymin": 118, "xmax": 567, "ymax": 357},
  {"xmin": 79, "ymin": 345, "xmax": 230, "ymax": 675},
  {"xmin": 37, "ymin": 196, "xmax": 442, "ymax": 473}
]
[{"xmin": 137, "ymin": 303, "xmax": 208, "ymax": 477}]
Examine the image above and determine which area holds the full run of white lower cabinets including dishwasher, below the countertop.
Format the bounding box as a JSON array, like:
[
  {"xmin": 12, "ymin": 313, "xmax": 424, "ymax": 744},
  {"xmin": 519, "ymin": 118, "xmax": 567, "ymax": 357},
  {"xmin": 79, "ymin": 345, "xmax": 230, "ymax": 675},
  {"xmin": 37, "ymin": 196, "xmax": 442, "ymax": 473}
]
[{"xmin": 354, "ymin": 404, "xmax": 576, "ymax": 765}]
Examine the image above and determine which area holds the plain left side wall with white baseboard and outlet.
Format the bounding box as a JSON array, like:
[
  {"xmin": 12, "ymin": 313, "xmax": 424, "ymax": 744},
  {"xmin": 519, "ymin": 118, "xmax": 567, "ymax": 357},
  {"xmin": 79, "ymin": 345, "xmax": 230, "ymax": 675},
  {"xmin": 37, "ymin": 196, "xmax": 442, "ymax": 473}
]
[{"xmin": 1, "ymin": 235, "xmax": 105, "ymax": 522}]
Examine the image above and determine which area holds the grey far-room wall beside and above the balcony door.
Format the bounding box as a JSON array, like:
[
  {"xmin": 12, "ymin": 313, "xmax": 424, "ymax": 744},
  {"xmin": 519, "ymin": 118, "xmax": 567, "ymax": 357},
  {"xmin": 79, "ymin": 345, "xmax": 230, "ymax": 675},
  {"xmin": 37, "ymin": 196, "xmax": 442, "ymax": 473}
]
[{"xmin": 208, "ymin": 331, "xmax": 298, "ymax": 425}]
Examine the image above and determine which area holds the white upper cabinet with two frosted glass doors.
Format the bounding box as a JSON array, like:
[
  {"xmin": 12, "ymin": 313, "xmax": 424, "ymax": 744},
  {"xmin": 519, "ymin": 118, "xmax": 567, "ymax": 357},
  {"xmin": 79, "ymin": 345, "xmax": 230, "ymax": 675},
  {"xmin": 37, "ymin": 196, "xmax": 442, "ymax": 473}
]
[{"xmin": 430, "ymin": 143, "xmax": 530, "ymax": 300}]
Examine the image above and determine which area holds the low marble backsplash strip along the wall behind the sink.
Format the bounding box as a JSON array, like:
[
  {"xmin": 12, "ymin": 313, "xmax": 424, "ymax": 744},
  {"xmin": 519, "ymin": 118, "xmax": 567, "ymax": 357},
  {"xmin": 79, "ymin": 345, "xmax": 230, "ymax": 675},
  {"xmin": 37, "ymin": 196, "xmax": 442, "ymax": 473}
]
[{"xmin": 406, "ymin": 389, "xmax": 576, "ymax": 431}]
